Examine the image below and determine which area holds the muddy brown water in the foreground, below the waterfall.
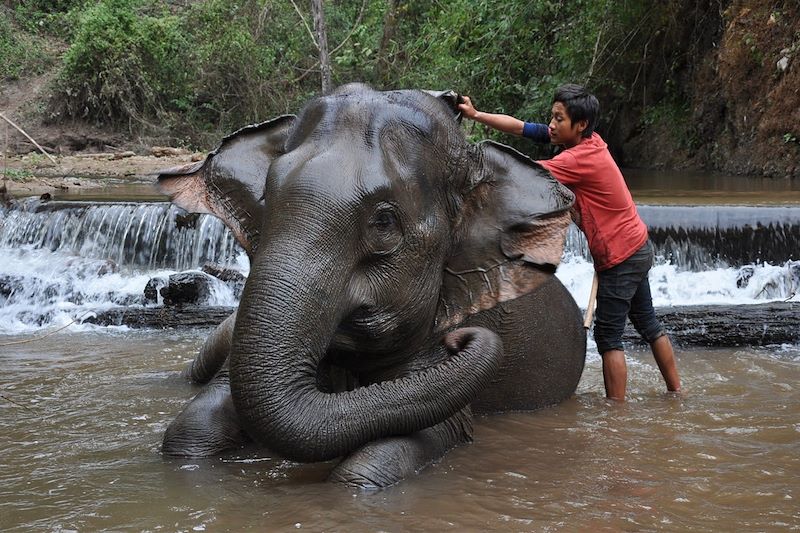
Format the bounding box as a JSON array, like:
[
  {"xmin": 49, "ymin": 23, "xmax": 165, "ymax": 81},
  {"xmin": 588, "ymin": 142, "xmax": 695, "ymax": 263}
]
[{"xmin": 0, "ymin": 330, "xmax": 800, "ymax": 531}]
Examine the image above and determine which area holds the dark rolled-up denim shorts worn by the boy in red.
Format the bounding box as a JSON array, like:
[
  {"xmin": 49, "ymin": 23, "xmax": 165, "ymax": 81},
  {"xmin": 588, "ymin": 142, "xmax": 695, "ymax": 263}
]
[{"xmin": 594, "ymin": 239, "xmax": 666, "ymax": 355}]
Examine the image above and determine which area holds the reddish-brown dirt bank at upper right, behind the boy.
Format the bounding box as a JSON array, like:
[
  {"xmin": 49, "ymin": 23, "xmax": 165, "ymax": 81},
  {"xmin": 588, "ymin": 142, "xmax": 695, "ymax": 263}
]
[{"xmin": 624, "ymin": 0, "xmax": 800, "ymax": 179}]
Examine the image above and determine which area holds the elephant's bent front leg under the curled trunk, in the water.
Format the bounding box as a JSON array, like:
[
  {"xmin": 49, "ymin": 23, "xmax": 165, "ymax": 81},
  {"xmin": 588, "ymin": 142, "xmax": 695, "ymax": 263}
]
[{"xmin": 328, "ymin": 407, "xmax": 472, "ymax": 490}]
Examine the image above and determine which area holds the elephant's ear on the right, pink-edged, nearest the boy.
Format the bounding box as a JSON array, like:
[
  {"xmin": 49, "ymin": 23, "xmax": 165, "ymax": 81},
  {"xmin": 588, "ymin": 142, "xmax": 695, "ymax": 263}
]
[{"xmin": 438, "ymin": 141, "xmax": 575, "ymax": 327}]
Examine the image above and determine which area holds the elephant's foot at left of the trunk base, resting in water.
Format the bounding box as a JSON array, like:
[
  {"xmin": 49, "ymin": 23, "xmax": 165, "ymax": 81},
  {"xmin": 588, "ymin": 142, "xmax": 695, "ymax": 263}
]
[{"xmin": 161, "ymin": 371, "xmax": 250, "ymax": 457}]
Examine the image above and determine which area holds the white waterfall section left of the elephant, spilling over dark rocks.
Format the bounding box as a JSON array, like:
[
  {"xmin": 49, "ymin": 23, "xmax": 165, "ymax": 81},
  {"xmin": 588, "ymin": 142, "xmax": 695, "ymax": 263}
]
[{"xmin": 0, "ymin": 198, "xmax": 248, "ymax": 333}]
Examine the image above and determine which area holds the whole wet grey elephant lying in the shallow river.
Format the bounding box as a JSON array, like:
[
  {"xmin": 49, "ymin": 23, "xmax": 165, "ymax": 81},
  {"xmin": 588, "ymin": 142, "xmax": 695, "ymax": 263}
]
[{"xmin": 158, "ymin": 84, "xmax": 586, "ymax": 489}]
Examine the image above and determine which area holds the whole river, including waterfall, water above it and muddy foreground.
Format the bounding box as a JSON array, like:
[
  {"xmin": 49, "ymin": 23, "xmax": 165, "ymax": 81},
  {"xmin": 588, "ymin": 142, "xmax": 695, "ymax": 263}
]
[{"xmin": 0, "ymin": 172, "xmax": 800, "ymax": 531}]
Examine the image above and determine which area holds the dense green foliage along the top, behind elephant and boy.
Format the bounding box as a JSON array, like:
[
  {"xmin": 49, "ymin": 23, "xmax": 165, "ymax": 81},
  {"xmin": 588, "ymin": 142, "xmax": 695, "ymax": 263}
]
[{"xmin": 17, "ymin": 0, "xmax": 720, "ymax": 146}]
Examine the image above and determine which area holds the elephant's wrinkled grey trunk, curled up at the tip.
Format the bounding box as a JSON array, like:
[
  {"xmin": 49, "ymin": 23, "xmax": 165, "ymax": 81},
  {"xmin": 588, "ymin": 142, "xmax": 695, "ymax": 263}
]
[{"xmin": 230, "ymin": 237, "xmax": 502, "ymax": 462}]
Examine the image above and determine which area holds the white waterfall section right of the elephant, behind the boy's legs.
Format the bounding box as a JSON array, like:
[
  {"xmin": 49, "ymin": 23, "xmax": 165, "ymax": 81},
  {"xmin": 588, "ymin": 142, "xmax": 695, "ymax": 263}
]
[{"xmin": 556, "ymin": 206, "xmax": 800, "ymax": 306}]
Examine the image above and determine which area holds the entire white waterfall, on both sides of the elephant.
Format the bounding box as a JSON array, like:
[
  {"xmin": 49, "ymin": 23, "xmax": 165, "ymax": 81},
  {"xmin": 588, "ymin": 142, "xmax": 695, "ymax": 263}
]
[{"xmin": 0, "ymin": 199, "xmax": 800, "ymax": 333}]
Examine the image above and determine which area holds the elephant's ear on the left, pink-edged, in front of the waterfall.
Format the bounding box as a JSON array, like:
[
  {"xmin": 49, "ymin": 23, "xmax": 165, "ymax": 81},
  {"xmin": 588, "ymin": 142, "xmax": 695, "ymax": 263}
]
[{"xmin": 158, "ymin": 115, "xmax": 295, "ymax": 255}]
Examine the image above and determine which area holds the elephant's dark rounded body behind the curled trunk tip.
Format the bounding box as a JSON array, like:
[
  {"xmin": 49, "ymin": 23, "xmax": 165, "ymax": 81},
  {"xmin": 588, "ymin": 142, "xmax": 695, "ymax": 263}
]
[{"xmin": 465, "ymin": 275, "xmax": 586, "ymax": 413}]
